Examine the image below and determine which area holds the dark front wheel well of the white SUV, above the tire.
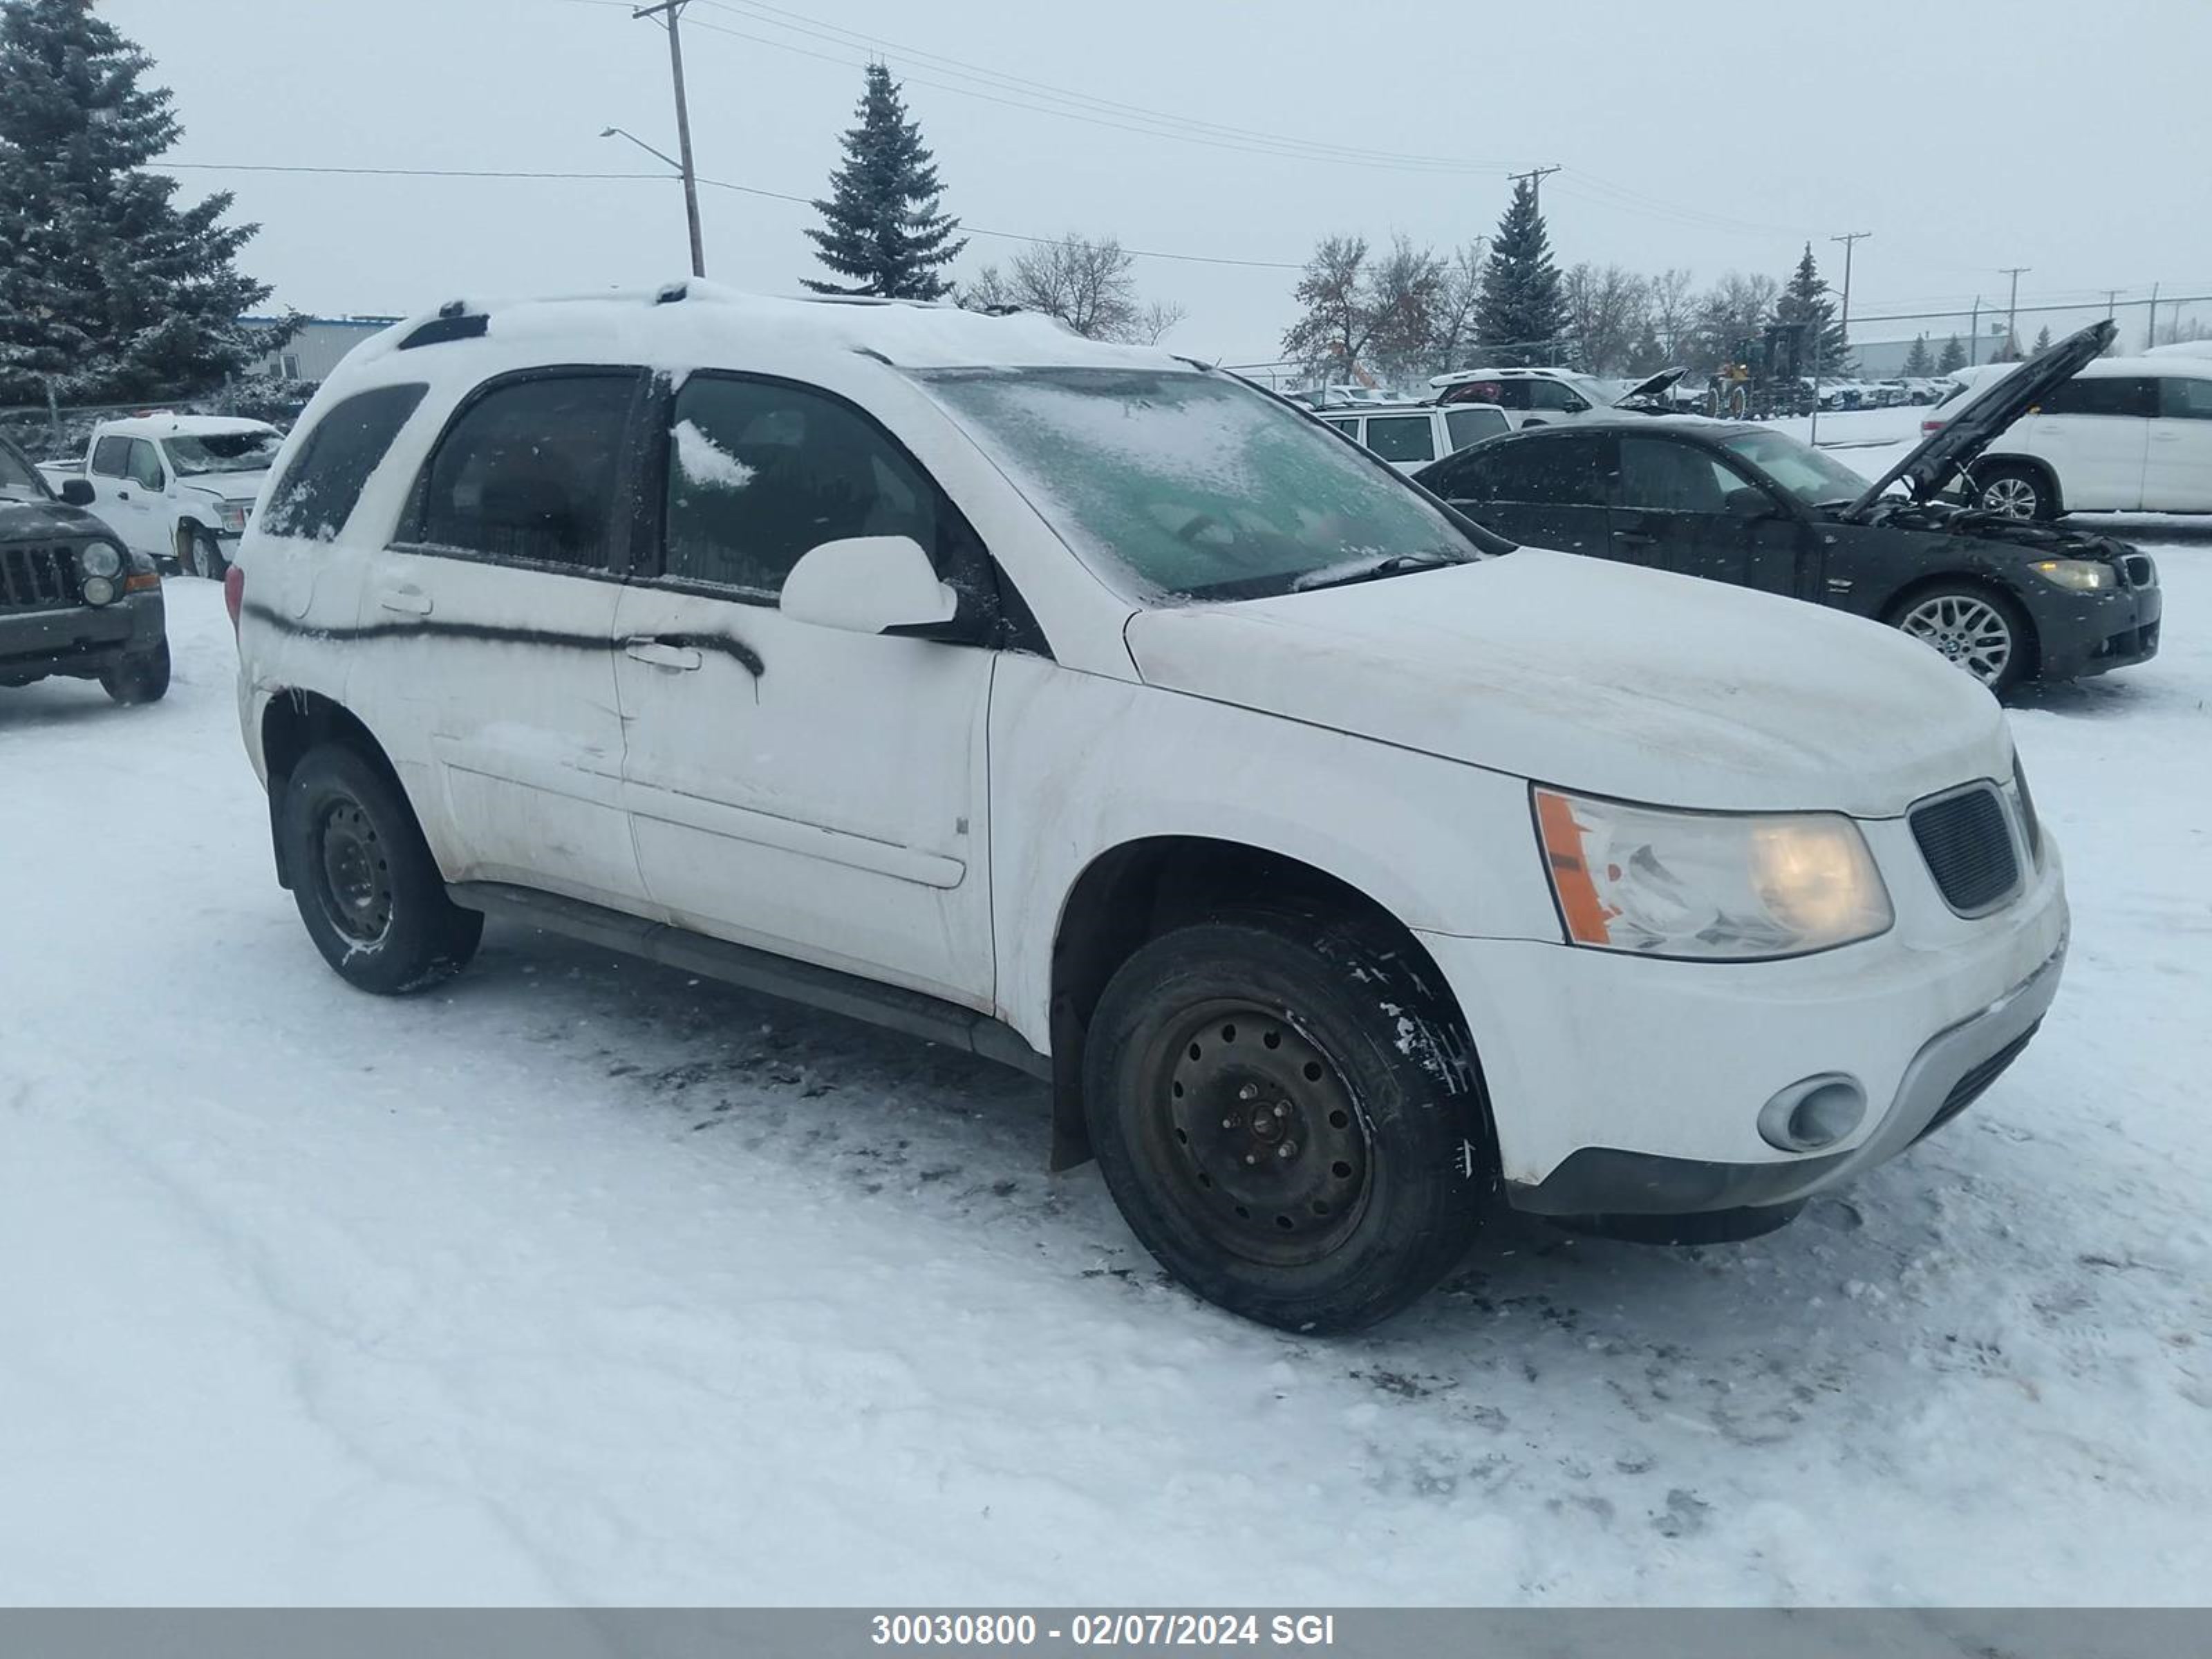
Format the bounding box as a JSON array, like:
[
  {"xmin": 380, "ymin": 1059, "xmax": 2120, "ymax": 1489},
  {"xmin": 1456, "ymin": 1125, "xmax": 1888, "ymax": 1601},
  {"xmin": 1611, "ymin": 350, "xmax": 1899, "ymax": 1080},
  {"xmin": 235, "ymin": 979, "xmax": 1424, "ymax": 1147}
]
[{"xmin": 1051, "ymin": 836, "xmax": 1458, "ymax": 1170}]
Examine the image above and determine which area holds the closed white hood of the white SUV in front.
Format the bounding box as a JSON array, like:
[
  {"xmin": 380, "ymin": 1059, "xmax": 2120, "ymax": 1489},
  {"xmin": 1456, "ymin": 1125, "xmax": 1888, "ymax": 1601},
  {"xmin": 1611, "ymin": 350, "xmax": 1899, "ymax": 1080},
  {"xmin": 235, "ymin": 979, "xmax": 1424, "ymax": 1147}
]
[{"xmin": 1128, "ymin": 549, "xmax": 2011, "ymax": 818}]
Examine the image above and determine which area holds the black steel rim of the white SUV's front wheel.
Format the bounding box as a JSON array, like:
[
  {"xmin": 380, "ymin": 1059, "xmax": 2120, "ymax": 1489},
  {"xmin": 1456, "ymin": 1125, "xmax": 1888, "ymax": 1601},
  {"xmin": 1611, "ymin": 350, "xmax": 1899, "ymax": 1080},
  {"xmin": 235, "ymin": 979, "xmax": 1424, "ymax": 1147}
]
[{"xmin": 1137, "ymin": 1000, "xmax": 1374, "ymax": 1268}]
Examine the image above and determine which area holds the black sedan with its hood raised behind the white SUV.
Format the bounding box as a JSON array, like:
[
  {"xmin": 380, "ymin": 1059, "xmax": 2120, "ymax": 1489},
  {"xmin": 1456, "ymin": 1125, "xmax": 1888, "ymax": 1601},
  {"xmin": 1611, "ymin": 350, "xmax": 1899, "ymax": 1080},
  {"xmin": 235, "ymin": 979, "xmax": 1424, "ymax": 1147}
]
[{"xmin": 1414, "ymin": 323, "xmax": 2161, "ymax": 693}]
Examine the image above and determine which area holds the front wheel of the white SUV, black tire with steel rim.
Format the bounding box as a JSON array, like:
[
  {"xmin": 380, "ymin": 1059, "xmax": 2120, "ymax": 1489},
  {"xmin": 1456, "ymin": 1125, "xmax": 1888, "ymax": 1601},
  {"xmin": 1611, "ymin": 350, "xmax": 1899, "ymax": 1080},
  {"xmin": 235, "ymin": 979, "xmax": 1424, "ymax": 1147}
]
[{"xmin": 1084, "ymin": 911, "xmax": 1495, "ymax": 1331}]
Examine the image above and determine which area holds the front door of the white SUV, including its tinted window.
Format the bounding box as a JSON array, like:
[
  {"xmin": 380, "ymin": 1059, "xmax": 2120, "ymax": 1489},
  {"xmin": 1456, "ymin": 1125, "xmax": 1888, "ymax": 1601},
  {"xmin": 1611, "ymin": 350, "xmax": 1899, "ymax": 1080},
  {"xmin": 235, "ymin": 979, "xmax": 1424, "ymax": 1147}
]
[{"xmin": 615, "ymin": 374, "xmax": 995, "ymax": 1009}]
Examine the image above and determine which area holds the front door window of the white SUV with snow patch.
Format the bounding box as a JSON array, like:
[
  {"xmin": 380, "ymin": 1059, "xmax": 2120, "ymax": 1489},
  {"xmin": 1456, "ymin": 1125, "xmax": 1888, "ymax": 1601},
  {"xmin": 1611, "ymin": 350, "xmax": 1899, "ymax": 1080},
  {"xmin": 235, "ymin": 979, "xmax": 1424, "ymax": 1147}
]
[{"xmin": 664, "ymin": 376, "xmax": 940, "ymax": 597}]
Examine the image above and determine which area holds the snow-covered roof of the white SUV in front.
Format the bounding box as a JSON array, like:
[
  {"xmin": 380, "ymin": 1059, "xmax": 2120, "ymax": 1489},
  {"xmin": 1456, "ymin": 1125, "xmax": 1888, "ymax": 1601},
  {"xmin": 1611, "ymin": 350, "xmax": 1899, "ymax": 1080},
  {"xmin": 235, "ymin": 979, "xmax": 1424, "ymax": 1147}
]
[{"xmin": 347, "ymin": 281, "xmax": 1177, "ymax": 380}]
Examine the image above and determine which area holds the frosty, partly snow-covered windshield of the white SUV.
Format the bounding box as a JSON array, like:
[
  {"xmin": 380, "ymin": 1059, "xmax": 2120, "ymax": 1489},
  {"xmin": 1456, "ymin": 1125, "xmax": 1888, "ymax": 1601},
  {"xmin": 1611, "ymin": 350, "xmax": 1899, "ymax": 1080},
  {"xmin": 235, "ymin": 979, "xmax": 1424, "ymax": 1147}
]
[{"xmin": 918, "ymin": 369, "xmax": 1504, "ymax": 601}]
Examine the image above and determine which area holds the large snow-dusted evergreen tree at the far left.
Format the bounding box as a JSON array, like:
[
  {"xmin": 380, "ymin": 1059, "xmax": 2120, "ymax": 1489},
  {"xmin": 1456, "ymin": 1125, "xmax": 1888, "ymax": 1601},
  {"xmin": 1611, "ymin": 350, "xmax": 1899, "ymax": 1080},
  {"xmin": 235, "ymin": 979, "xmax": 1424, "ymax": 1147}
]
[{"xmin": 0, "ymin": 0, "xmax": 270, "ymax": 402}]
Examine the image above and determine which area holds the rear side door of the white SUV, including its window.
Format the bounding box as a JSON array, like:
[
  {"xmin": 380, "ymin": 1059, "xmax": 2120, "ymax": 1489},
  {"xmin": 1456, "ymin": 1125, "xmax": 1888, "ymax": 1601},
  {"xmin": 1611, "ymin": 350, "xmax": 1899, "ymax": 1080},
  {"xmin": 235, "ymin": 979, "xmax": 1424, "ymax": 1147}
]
[{"xmin": 352, "ymin": 367, "xmax": 650, "ymax": 914}]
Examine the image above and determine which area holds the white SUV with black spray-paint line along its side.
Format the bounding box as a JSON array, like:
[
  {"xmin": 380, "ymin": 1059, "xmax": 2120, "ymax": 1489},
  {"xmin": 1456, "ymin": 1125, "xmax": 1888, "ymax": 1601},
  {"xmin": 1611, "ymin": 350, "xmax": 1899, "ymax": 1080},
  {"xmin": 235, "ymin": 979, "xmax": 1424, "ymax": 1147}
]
[{"xmin": 228, "ymin": 285, "xmax": 2066, "ymax": 1329}]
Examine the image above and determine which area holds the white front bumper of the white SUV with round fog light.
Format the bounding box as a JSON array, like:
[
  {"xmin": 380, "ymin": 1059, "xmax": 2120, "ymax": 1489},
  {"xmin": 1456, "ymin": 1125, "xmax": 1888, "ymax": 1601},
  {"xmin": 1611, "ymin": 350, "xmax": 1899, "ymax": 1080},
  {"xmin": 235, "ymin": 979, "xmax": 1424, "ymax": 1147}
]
[{"xmin": 1420, "ymin": 818, "xmax": 2068, "ymax": 1215}]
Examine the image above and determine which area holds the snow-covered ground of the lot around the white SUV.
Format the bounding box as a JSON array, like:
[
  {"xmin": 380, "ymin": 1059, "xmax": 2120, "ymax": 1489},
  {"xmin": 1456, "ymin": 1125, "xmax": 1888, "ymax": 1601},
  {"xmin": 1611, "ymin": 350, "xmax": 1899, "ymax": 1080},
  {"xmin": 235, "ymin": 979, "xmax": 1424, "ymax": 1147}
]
[{"xmin": 0, "ymin": 500, "xmax": 2212, "ymax": 1604}]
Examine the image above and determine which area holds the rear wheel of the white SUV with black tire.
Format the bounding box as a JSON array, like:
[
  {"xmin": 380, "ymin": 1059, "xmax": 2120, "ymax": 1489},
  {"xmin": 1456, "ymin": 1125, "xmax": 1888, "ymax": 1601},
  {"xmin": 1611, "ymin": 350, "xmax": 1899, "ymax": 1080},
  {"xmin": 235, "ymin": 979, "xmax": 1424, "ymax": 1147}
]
[{"xmin": 281, "ymin": 743, "xmax": 485, "ymax": 995}]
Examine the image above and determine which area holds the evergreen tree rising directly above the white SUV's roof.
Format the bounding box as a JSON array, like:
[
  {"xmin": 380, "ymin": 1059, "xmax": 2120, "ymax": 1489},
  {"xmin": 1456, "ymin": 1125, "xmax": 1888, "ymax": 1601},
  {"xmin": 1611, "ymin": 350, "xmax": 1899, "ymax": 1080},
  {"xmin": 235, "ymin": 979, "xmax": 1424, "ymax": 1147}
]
[{"xmin": 805, "ymin": 64, "xmax": 966, "ymax": 299}]
